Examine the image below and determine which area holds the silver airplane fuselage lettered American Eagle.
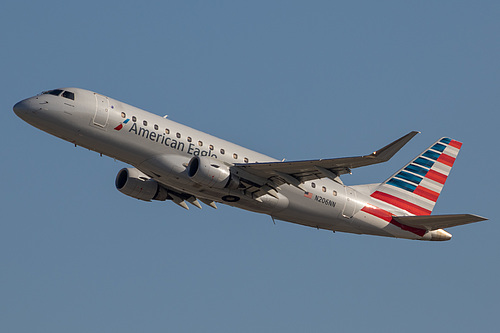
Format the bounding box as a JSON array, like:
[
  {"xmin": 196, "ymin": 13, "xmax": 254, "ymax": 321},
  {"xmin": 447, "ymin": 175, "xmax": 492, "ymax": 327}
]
[{"xmin": 14, "ymin": 88, "xmax": 449, "ymax": 240}]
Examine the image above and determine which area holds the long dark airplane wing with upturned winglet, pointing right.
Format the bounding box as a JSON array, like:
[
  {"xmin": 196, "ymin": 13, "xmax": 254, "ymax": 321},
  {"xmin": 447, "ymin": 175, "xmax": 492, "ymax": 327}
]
[{"xmin": 232, "ymin": 131, "xmax": 419, "ymax": 192}]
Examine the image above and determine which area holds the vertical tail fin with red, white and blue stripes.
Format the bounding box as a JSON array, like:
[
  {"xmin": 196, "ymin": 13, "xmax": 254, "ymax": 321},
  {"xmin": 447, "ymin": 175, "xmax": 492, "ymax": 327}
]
[{"xmin": 371, "ymin": 138, "xmax": 462, "ymax": 215}]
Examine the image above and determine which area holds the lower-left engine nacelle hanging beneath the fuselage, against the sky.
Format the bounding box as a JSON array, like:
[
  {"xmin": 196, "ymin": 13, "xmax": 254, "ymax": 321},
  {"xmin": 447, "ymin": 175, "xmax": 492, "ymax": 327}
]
[{"xmin": 115, "ymin": 168, "xmax": 168, "ymax": 201}]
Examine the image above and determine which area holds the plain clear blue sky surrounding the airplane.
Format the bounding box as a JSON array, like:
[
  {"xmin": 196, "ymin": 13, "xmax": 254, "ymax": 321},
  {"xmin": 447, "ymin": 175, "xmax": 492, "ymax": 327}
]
[{"xmin": 0, "ymin": 0, "xmax": 500, "ymax": 333}]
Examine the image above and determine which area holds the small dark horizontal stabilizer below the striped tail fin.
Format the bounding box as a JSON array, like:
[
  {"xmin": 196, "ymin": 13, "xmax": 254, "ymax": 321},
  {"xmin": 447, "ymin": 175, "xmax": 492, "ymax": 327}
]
[{"xmin": 393, "ymin": 214, "xmax": 487, "ymax": 230}]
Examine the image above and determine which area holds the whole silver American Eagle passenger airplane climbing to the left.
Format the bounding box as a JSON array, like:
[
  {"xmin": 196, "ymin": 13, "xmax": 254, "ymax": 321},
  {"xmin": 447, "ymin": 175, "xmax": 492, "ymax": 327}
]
[{"xmin": 13, "ymin": 88, "xmax": 487, "ymax": 241}]
